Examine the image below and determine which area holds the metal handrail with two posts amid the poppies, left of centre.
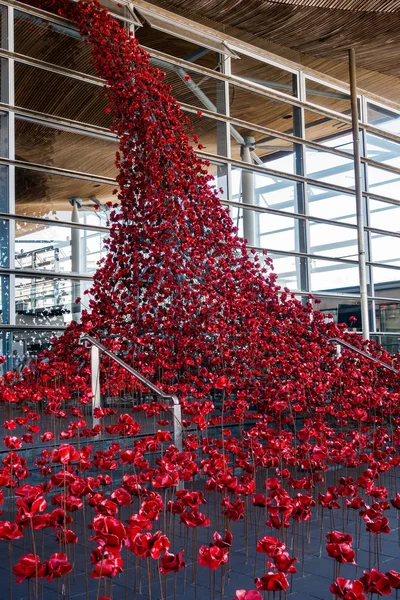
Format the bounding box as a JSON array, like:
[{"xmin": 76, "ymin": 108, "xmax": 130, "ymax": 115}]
[{"xmin": 81, "ymin": 335, "xmax": 182, "ymax": 451}]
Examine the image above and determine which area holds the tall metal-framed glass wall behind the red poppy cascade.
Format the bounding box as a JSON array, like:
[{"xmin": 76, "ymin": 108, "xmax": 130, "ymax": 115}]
[{"xmin": 0, "ymin": 0, "xmax": 400, "ymax": 356}]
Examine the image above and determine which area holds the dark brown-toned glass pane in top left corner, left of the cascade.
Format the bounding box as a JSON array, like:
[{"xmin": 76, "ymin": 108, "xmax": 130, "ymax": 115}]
[{"xmin": 14, "ymin": 10, "xmax": 95, "ymax": 75}]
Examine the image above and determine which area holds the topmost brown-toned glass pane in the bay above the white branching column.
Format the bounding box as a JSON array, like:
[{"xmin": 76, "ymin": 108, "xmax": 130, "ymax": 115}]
[{"xmin": 231, "ymin": 52, "xmax": 297, "ymax": 96}]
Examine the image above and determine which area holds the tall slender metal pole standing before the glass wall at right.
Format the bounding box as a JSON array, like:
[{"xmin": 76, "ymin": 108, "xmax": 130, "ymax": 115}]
[{"xmin": 349, "ymin": 48, "xmax": 369, "ymax": 340}]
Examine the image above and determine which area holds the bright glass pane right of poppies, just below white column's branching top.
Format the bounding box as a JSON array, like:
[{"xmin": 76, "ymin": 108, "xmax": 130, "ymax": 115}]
[{"xmin": 232, "ymin": 167, "xmax": 298, "ymax": 212}]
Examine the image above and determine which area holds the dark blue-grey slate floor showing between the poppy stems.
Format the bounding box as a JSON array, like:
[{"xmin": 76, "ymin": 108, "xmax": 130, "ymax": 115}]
[{"xmin": 0, "ymin": 398, "xmax": 400, "ymax": 600}]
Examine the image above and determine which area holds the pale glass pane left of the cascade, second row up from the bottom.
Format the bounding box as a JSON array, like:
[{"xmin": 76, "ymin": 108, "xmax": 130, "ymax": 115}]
[{"xmin": 15, "ymin": 277, "xmax": 91, "ymax": 326}]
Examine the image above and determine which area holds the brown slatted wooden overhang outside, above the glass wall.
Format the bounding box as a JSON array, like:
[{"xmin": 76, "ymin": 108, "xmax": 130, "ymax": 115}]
[{"xmin": 152, "ymin": 0, "xmax": 400, "ymax": 77}]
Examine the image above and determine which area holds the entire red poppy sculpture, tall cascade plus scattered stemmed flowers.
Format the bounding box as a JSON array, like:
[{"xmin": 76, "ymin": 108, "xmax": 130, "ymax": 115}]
[{"xmin": 0, "ymin": 0, "xmax": 400, "ymax": 600}]
